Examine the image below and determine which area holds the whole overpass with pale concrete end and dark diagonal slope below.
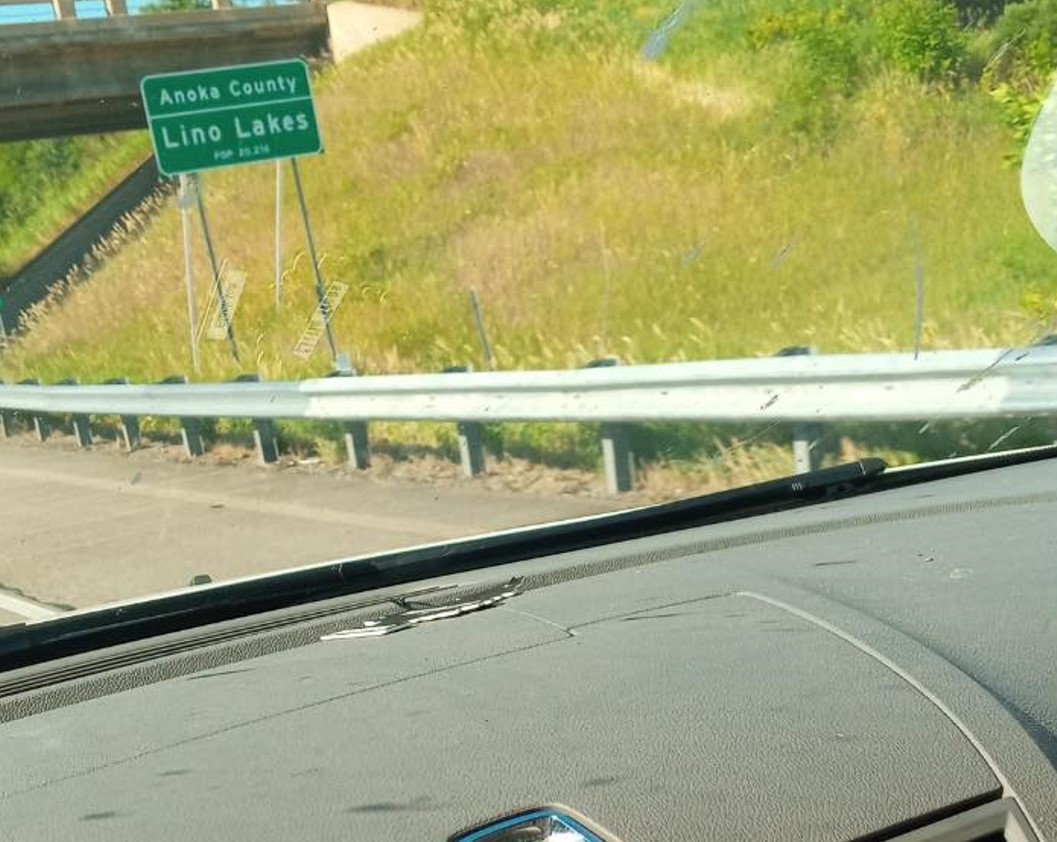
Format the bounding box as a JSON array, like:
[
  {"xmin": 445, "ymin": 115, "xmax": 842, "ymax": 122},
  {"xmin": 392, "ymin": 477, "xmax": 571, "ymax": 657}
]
[{"xmin": 0, "ymin": 0, "xmax": 420, "ymax": 331}]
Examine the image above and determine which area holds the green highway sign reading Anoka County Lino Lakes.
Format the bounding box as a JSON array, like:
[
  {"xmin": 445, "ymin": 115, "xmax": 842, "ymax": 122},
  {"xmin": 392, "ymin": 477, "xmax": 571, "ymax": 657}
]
[{"xmin": 140, "ymin": 59, "xmax": 322, "ymax": 175}]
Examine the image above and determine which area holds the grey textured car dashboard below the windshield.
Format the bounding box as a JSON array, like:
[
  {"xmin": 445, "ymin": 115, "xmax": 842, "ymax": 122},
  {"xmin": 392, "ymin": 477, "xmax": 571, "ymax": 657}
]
[{"xmin": 0, "ymin": 460, "xmax": 1057, "ymax": 842}]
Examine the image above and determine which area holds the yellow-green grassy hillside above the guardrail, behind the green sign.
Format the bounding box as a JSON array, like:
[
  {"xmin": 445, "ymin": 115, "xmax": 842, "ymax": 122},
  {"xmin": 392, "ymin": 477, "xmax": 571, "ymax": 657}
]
[{"xmin": 0, "ymin": 0, "xmax": 1057, "ymax": 473}]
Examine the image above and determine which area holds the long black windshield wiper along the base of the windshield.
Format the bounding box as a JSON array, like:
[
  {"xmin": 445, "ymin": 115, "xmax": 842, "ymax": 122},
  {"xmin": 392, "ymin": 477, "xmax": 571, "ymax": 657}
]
[{"xmin": 8, "ymin": 446, "xmax": 1057, "ymax": 674}]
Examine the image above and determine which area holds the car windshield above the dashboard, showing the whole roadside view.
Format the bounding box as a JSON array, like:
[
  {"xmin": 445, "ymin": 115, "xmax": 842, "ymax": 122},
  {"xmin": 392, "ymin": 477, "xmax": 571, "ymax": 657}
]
[{"xmin": 0, "ymin": 0, "xmax": 1057, "ymax": 624}]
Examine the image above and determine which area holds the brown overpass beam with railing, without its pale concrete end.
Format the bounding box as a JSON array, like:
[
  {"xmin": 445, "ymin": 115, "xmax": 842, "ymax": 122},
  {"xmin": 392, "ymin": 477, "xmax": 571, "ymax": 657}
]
[{"xmin": 0, "ymin": 0, "xmax": 345, "ymax": 143}]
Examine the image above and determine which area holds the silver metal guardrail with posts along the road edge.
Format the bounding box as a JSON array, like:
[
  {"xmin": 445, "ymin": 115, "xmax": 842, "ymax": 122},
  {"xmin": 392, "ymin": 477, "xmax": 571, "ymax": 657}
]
[{"xmin": 0, "ymin": 347, "xmax": 1057, "ymax": 490}]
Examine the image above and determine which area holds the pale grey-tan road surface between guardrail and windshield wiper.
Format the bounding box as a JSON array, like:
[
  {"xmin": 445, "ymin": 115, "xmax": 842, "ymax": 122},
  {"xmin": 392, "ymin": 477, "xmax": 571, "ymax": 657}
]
[{"xmin": 0, "ymin": 436, "xmax": 617, "ymax": 623}]
